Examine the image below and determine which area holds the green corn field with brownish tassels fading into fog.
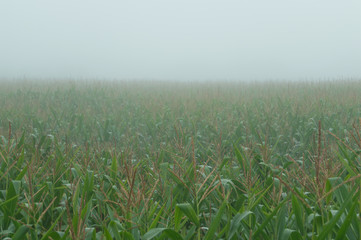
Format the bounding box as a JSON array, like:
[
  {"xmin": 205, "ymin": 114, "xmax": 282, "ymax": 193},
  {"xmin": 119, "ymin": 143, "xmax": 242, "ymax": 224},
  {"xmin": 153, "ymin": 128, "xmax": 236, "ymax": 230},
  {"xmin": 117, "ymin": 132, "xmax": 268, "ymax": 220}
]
[{"xmin": 0, "ymin": 81, "xmax": 361, "ymax": 240}]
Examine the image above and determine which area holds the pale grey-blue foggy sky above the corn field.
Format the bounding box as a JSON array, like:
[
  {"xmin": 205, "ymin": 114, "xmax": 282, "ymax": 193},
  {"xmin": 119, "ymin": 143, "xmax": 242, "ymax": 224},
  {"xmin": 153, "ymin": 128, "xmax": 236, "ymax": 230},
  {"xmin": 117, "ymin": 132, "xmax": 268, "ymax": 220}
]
[{"xmin": 0, "ymin": 0, "xmax": 361, "ymax": 80}]
